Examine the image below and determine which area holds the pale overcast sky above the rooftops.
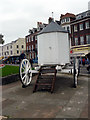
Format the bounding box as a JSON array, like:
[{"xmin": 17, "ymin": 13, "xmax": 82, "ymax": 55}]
[{"xmin": 0, "ymin": 0, "xmax": 89, "ymax": 44}]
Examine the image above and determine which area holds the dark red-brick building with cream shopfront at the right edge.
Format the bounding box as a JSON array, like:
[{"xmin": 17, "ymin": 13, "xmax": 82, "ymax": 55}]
[{"xmin": 71, "ymin": 10, "xmax": 90, "ymax": 56}]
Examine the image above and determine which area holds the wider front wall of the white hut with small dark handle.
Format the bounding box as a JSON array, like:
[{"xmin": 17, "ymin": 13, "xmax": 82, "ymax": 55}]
[{"xmin": 38, "ymin": 32, "xmax": 58, "ymax": 64}]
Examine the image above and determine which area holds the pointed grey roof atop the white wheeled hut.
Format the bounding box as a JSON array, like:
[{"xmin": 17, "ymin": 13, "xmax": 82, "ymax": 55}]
[{"xmin": 38, "ymin": 21, "xmax": 67, "ymax": 34}]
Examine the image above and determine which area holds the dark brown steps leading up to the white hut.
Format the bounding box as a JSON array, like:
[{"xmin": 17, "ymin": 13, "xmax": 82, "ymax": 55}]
[{"xmin": 33, "ymin": 66, "xmax": 56, "ymax": 93}]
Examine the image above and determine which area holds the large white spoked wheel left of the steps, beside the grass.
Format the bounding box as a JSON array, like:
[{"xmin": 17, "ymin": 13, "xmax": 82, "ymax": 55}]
[{"xmin": 19, "ymin": 59, "xmax": 32, "ymax": 87}]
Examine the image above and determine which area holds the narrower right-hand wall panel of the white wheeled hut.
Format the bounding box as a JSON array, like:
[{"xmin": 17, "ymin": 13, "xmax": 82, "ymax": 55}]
[{"xmin": 57, "ymin": 32, "xmax": 70, "ymax": 64}]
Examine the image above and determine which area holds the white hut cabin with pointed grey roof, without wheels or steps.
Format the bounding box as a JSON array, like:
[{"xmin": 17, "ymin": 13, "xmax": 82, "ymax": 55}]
[{"xmin": 38, "ymin": 21, "xmax": 70, "ymax": 65}]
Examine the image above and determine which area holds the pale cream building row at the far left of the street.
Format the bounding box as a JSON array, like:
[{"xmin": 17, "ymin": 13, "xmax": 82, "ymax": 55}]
[{"xmin": 1, "ymin": 38, "xmax": 26, "ymax": 61}]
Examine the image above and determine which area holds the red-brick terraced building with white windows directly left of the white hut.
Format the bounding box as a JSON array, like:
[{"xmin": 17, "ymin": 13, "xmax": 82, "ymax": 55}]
[{"xmin": 25, "ymin": 22, "xmax": 47, "ymax": 60}]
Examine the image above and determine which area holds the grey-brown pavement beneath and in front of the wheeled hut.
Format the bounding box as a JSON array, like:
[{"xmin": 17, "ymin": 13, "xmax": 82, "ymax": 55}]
[{"xmin": 1, "ymin": 73, "xmax": 89, "ymax": 118}]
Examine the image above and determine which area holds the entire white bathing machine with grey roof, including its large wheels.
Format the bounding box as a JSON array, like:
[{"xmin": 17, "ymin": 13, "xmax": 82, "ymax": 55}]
[{"xmin": 20, "ymin": 21, "xmax": 78, "ymax": 92}]
